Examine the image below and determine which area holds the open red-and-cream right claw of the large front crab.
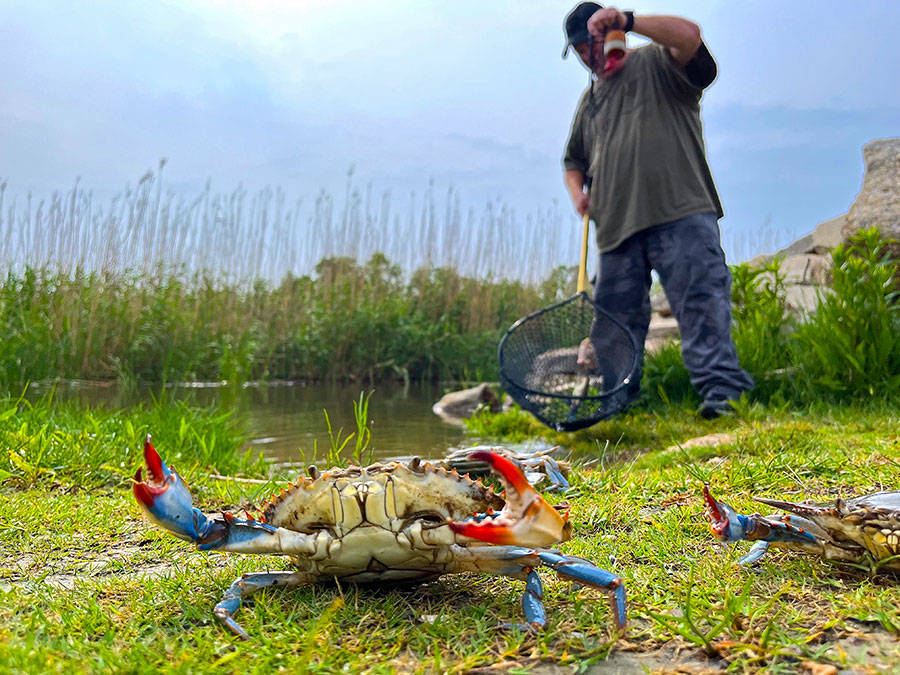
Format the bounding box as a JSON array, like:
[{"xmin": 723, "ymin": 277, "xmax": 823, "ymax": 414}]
[{"xmin": 449, "ymin": 450, "xmax": 572, "ymax": 548}]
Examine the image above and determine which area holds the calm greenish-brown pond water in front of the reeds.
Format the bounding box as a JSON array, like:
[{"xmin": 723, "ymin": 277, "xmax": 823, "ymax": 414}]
[{"xmin": 29, "ymin": 382, "xmax": 478, "ymax": 462}]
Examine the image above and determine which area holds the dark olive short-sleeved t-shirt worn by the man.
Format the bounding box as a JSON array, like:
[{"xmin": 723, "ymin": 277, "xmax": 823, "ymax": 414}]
[{"xmin": 563, "ymin": 43, "xmax": 722, "ymax": 252}]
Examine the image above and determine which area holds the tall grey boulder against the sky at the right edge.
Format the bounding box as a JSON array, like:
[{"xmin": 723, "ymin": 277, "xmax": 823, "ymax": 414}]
[{"xmin": 841, "ymin": 138, "xmax": 900, "ymax": 258}]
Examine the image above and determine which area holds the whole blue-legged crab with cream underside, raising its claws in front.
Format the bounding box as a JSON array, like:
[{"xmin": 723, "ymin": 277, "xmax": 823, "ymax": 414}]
[{"xmin": 133, "ymin": 436, "xmax": 625, "ymax": 638}]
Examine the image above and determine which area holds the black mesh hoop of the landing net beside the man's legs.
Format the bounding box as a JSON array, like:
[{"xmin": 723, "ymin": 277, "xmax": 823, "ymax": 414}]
[{"xmin": 498, "ymin": 293, "xmax": 640, "ymax": 431}]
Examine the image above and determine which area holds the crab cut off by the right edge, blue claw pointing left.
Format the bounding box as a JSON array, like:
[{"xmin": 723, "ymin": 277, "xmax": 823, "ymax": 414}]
[{"xmin": 703, "ymin": 485, "xmax": 900, "ymax": 572}]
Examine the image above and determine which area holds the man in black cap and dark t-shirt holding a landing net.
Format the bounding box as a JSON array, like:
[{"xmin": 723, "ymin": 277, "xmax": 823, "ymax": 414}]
[{"xmin": 563, "ymin": 2, "xmax": 753, "ymax": 419}]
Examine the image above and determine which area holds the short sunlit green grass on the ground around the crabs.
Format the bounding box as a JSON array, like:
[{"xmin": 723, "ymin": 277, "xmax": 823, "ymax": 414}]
[{"xmin": 0, "ymin": 404, "xmax": 900, "ymax": 673}]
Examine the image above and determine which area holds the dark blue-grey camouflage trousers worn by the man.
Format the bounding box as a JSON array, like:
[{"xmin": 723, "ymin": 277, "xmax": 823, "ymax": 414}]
[{"xmin": 594, "ymin": 213, "xmax": 753, "ymax": 401}]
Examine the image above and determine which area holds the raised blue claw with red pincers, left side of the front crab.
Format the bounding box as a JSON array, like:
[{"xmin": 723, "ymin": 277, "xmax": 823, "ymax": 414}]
[{"xmin": 131, "ymin": 434, "xmax": 218, "ymax": 543}]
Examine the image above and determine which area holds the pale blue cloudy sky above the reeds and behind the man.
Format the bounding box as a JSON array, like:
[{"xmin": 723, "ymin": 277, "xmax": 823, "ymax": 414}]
[{"xmin": 0, "ymin": 0, "xmax": 900, "ymax": 270}]
